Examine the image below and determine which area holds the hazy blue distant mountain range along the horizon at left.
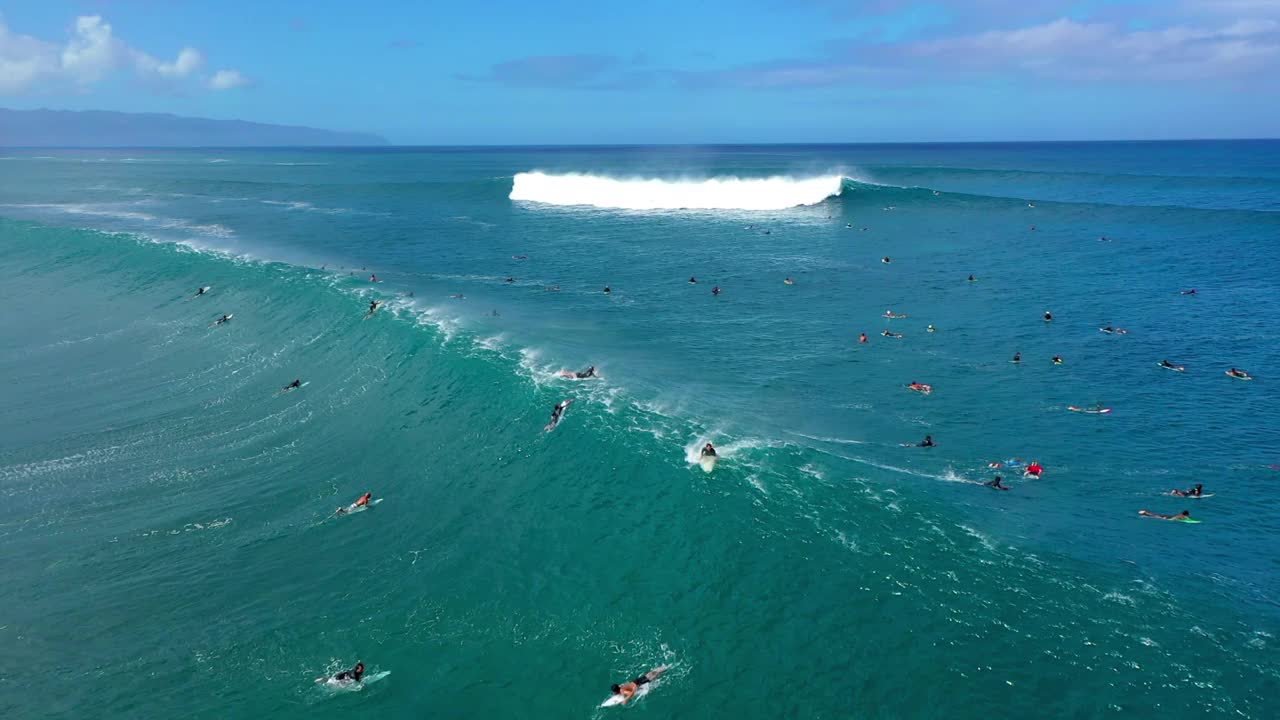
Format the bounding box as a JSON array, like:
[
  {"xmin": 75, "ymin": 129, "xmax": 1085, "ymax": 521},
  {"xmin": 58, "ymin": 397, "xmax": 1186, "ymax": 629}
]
[{"xmin": 0, "ymin": 108, "xmax": 387, "ymax": 147}]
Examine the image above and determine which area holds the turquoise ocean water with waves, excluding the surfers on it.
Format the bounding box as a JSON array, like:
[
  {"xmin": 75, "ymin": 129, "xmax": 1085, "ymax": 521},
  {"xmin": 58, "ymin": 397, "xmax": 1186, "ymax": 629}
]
[{"xmin": 0, "ymin": 142, "xmax": 1280, "ymax": 719}]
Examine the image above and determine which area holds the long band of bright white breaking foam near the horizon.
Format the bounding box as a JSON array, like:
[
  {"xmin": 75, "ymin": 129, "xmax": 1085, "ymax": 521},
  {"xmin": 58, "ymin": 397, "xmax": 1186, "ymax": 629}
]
[{"xmin": 511, "ymin": 170, "xmax": 845, "ymax": 210}]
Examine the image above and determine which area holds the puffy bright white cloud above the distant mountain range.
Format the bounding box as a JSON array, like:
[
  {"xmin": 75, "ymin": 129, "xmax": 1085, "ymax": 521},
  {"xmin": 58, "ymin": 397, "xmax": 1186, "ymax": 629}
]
[{"xmin": 0, "ymin": 15, "xmax": 247, "ymax": 95}]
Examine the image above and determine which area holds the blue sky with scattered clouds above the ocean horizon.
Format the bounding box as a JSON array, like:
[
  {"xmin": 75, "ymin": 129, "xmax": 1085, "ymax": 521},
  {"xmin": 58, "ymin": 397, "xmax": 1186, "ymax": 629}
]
[{"xmin": 0, "ymin": 0, "xmax": 1280, "ymax": 145}]
